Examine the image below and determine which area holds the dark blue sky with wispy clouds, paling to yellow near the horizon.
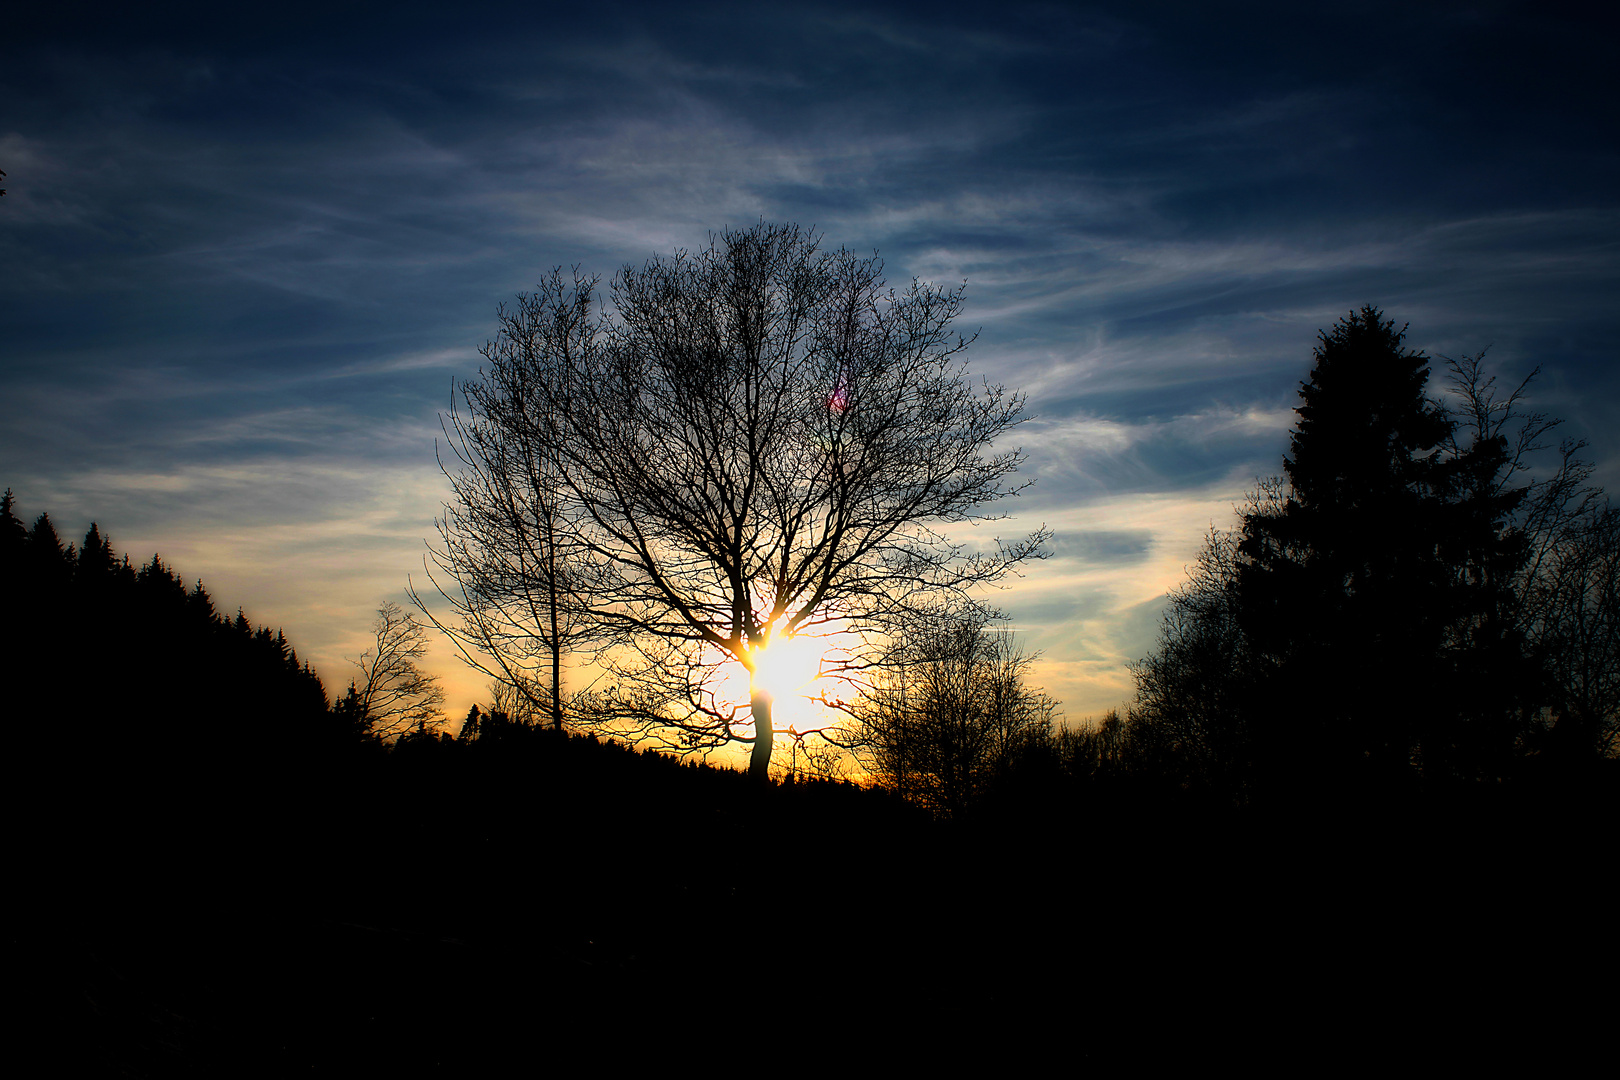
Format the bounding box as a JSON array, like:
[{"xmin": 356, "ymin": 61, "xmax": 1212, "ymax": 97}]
[{"xmin": 0, "ymin": 3, "xmax": 1620, "ymax": 735}]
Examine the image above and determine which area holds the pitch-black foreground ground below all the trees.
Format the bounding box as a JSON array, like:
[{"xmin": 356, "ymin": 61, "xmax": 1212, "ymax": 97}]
[{"xmin": 11, "ymin": 740, "xmax": 1617, "ymax": 1077}]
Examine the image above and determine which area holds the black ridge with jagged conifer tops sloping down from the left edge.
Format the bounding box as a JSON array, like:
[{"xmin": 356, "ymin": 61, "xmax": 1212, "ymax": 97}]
[{"xmin": 0, "ymin": 492, "xmax": 358, "ymax": 844}]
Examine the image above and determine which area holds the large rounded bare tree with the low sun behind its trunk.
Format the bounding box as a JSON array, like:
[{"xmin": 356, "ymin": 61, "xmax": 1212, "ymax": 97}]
[{"xmin": 436, "ymin": 223, "xmax": 1045, "ymax": 777}]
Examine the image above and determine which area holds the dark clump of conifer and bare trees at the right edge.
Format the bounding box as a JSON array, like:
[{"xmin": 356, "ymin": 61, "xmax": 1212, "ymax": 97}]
[{"xmin": 1108, "ymin": 306, "xmax": 1620, "ymax": 800}]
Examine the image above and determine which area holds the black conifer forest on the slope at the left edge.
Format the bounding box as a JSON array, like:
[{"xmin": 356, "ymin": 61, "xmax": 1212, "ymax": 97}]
[{"xmin": 0, "ymin": 491, "xmax": 340, "ymax": 767}]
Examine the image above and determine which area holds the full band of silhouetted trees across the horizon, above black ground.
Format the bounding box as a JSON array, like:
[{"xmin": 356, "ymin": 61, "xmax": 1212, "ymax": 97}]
[{"xmin": 9, "ymin": 233, "xmax": 1620, "ymax": 816}]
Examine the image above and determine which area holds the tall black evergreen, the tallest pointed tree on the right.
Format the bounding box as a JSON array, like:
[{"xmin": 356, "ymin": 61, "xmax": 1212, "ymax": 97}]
[{"xmin": 1236, "ymin": 306, "xmax": 1523, "ymax": 784}]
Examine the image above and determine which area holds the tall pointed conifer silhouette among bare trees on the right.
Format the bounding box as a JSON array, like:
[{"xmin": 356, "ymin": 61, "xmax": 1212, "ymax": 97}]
[{"xmin": 1238, "ymin": 306, "xmax": 1486, "ymax": 777}]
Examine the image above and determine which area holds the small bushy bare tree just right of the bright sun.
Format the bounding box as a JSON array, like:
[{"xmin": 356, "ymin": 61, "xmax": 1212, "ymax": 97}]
[{"xmin": 857, "ymin": 607, "xmax": 1056, "ymax": 816}]
